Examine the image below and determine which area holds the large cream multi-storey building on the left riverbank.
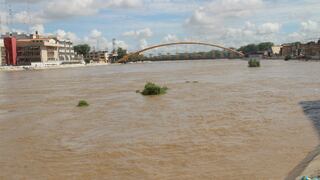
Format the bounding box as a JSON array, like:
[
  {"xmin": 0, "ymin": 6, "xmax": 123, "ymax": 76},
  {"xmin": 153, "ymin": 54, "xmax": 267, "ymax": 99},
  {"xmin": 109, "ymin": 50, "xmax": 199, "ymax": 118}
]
[{"xmin": 2, "ymin": 32, "xmax": 83, "ymax": 65}]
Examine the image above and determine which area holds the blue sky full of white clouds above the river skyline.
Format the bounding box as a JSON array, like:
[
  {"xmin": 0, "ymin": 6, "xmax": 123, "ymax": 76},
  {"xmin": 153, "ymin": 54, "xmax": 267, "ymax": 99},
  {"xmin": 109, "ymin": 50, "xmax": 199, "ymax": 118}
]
[{"xmin": 0, "ymin": 0, "xmax": 320, "ymax": 50}]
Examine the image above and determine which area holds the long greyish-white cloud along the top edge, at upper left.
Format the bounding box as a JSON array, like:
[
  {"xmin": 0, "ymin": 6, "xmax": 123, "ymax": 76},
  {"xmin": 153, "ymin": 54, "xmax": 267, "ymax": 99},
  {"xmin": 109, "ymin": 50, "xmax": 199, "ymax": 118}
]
[{"xmin": 10, "ymin": 0, "xmax": 143, "ymax": 24}]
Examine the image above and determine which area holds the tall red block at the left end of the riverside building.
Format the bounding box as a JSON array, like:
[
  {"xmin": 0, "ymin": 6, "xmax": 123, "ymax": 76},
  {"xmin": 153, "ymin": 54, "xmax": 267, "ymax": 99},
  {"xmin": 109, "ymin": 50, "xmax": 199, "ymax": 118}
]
[{"xmin": 3, "ymin": 37, "xmax": 17, "ymax": 66}]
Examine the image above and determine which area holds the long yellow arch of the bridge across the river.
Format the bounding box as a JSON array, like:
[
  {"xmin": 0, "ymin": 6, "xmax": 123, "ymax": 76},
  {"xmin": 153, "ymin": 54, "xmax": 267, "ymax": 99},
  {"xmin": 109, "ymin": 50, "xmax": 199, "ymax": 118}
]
[{"xmin": 118, "ymin": 42, "xmax": 244, "ymax": 63}]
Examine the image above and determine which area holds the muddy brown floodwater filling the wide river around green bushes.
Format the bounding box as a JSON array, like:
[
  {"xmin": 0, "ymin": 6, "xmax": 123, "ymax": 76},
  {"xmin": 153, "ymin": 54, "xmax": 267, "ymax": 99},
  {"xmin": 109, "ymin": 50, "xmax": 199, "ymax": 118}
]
[{"xmin": 0, "ymin": 60, "xmax": 320, "ymax": 179}]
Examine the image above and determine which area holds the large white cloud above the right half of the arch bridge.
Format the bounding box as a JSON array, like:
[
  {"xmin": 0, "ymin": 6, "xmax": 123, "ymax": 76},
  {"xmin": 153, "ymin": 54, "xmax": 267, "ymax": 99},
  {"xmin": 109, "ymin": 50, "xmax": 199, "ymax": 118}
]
[{"xmin": 185, "ymin": 0, "xmax": 282, "ymax": 47}]
